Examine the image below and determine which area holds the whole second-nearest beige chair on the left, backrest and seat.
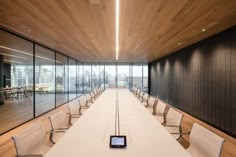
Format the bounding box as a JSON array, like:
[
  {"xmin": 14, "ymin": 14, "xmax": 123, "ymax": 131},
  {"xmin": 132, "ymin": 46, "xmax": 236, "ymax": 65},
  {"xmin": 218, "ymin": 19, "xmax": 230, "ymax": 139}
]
[{"xmin": 49, "ymin": 110, "xmax": 69, "ymax": 144}]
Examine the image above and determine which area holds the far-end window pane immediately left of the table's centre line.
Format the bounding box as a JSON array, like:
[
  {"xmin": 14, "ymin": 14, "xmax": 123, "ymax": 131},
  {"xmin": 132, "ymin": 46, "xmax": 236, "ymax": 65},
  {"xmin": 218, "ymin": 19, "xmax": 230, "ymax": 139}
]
[{"xmin": 105, "ymin": 65, "xmax": 116, "ymax": 88}]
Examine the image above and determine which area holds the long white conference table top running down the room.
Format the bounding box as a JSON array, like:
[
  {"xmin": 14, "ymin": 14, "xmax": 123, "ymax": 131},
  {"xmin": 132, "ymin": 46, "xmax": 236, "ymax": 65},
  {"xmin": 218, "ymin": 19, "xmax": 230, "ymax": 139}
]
[{"xmin": 44, "ymin": 89, "xmax": 190, "ymax": 157}]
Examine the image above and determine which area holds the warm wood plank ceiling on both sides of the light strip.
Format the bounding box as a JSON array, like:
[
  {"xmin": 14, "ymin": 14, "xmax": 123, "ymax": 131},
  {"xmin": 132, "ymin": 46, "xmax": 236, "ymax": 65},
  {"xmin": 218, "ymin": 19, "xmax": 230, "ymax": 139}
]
[{"xmin": 0, "ymin": 0, "xmax": 236, "ymax": 62}]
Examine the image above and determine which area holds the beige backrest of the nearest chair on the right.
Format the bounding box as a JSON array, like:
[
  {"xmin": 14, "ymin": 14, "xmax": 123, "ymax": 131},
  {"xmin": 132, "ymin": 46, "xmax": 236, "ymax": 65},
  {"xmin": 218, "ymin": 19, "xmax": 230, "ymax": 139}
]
[{"xmin": 187, "ymin": 123, "xmax": 224, "ymax": 157}]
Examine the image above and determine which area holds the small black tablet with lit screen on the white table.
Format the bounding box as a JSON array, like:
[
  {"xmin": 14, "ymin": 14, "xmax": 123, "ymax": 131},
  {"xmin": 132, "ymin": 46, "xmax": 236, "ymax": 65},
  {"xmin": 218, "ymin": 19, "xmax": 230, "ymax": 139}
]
[{"xmin": 110, "ymin": 136, "xmax": 126, "ymax": 148}]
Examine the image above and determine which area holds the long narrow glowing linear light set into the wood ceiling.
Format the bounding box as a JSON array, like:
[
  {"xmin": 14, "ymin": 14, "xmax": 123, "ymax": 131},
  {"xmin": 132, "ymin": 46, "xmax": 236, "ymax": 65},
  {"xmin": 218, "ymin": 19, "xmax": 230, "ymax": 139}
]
[{"xmin": 116, "ymin": 0, "xmax": 120, "ymax": 60}]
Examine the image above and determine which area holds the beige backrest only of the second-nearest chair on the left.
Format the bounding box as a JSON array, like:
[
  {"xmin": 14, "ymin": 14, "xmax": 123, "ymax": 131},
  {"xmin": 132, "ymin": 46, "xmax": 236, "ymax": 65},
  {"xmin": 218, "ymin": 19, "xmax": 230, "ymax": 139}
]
[{"xmin": 49, "ymin": 110, "xmax": 68, "ymax": 129}]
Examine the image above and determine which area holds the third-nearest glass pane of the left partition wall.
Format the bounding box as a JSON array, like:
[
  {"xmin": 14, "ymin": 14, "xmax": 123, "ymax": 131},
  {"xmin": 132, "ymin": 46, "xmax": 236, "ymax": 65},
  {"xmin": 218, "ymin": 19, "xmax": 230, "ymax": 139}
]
[{"xmin": 56, "ymin": 53, "xmax": 68, "ymax": 106}]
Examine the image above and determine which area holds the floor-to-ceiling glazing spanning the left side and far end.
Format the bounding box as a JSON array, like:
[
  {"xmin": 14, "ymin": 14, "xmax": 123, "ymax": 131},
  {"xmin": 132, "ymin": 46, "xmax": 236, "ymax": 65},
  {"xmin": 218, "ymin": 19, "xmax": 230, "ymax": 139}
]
[{"xmin": 0, "ymin": 29, "xmax": 148, "ymax": 134}]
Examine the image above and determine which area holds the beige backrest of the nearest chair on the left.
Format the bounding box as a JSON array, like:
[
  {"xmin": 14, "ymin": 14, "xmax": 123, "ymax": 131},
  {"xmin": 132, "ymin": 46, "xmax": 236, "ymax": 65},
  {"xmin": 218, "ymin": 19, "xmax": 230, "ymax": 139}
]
[{"xmin": 12, "ymin": 123, "xmax": 46, "ymax": 156}]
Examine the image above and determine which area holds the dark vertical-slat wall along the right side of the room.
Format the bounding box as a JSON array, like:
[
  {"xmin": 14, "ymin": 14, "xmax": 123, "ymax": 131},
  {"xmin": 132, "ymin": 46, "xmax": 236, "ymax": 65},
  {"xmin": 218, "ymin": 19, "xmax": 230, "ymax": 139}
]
[{"xmin": 149, "ymin": 26, "xmax": 236, "ymax": 137}]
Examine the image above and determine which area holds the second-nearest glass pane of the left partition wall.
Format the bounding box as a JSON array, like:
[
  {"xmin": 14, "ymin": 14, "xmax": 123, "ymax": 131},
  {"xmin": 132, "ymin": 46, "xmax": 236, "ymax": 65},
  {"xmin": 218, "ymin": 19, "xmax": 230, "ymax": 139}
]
[{"xmin": 35, "ymin": 45, "xmax": 55, "ymax": 116}]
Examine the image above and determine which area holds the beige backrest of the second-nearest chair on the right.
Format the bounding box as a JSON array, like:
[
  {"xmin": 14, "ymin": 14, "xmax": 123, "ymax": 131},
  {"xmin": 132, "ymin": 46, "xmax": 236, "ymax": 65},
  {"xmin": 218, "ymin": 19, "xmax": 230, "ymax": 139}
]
[{"xmin": 166, "ymin": 108, "xmax": 183, "ymax": 126}]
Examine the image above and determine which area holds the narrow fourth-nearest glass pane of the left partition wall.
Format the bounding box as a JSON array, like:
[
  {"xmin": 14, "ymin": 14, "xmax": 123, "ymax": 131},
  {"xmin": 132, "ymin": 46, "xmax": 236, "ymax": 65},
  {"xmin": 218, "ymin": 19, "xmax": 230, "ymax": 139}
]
[{"xmin": 69, "ymin": 58, "xmax": 77, "ymax": 100}]
